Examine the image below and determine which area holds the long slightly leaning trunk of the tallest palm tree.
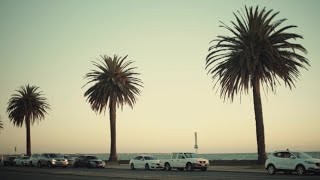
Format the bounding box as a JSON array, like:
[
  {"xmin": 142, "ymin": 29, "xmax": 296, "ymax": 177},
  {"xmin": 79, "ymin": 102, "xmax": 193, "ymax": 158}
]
[{"xmin": 252, "ymin": 79, "xmax": 267, "ymax": 164}]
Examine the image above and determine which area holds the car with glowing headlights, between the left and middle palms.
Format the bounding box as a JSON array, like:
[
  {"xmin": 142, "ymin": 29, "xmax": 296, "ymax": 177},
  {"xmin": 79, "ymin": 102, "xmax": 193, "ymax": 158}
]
[{"xmin": 38, "ymin": 153, "xmax": 68, "ymax": 168}]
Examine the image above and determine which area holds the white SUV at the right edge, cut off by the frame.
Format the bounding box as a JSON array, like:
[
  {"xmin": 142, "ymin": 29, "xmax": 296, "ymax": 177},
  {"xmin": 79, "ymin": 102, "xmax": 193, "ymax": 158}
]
[{"xmin": 265, "ymin": 150, "xmax": 320, "ymax": 175}]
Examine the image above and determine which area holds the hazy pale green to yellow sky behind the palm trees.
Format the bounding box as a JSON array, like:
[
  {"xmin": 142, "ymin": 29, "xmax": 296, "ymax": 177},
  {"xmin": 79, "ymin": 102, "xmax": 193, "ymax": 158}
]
[{"xmin": 0, "ymin": 0, "xmax": 320, "ymax": 154}]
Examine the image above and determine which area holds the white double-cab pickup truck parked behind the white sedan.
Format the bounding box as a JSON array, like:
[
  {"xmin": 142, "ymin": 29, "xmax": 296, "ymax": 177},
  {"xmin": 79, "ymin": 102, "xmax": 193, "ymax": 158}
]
[{"xmin": 160, "ymin": 152, "xmax": 210, "ymax": 171}]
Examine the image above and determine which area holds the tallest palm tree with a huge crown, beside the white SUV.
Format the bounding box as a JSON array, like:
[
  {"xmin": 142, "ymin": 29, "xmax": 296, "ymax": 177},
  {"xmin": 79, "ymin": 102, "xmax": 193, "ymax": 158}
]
[{"xmin": 206, "ymin": 6, "xmax": 309, "ymax": 163}]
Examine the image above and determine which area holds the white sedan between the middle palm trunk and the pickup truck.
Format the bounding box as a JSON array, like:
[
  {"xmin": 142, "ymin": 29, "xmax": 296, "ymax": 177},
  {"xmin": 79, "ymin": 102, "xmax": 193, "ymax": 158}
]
[{"xmin": 129, "ymin": 155, "xmax": 162, "ymax": 170}]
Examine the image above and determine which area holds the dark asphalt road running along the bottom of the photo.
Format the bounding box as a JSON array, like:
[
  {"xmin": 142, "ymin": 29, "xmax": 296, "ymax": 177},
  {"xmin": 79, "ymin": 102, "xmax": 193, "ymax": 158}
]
[{"xmin": 0, "ymin": 167, "xmax": 319, "ymax": 180}]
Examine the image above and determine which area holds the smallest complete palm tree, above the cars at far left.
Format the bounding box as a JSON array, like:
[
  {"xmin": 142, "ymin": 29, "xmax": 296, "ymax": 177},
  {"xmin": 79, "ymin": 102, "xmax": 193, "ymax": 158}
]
[{"xmin": 7, "ymin": 84, "xmax": 50, "ymax": 156}]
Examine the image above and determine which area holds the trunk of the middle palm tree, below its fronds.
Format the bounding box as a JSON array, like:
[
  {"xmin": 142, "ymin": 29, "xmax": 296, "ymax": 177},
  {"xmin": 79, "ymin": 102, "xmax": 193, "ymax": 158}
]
[{"xmin": 109, "ymin": 98, "xmax": 118, "ymax": 162}]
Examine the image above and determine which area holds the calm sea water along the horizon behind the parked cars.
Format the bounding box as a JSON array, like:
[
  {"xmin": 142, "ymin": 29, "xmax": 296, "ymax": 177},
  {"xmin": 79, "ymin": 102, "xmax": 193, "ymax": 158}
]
[{"xmin": 72, "ymin": 152, "xmax": 320, "ymax": 160}]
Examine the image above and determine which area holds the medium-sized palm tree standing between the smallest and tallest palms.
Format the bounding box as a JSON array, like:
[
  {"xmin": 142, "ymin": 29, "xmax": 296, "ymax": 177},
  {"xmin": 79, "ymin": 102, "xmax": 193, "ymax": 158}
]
[{"xmin": 84, "ymin": 55, "xmax": 142, "ymax": 162}]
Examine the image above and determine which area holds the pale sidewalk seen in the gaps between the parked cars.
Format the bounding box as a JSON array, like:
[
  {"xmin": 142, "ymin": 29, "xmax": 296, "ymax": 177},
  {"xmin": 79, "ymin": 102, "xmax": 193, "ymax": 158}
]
[{"xmin": 106, "ymin": 164, "xmax": 267, "ymax": 173}]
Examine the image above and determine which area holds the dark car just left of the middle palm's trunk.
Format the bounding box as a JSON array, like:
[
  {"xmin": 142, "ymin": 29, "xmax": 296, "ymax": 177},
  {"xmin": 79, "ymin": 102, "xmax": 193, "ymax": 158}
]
[{"xmin": 74, "ymin": 155, "xmax": 106, "ymax": 168}]
